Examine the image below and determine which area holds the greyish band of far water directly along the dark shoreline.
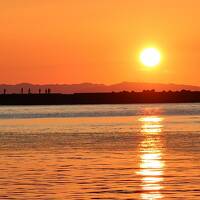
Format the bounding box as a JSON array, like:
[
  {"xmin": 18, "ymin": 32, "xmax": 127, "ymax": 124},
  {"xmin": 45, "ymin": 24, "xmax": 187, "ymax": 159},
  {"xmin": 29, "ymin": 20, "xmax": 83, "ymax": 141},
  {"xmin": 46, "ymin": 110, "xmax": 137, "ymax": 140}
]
[{"xmin": 0, "ymin": 104, "xmax": 200, "ymax": 119}]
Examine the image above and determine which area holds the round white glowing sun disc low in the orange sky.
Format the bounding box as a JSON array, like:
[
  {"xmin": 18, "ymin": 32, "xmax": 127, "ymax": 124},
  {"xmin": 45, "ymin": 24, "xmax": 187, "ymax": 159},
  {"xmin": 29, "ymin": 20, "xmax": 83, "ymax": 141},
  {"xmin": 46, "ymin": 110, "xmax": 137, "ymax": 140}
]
[{"xmin": 140, "ymin": 48, "xmax": 161, "ymax": 67}]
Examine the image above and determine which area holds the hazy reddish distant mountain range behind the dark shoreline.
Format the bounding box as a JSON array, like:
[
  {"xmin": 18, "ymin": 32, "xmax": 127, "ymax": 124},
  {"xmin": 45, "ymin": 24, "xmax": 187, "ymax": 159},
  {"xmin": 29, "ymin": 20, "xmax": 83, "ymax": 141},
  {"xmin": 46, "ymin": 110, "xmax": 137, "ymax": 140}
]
[{"xmin": 0, "ymin": 82, "xmax": 200, "ymax": 94}]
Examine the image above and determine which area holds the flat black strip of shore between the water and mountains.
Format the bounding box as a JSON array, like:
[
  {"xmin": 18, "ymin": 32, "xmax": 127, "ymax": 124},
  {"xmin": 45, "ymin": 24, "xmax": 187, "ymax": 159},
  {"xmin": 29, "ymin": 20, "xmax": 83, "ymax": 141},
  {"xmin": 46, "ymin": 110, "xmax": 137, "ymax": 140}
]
[{"xmin": 0, "ymin": 90, "xmax": 200, "ymax": 105}]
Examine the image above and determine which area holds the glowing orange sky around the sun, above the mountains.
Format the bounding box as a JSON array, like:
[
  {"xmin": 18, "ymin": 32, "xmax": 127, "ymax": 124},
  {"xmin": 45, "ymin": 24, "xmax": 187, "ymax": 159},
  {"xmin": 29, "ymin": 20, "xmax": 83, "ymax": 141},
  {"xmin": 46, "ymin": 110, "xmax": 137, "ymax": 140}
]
[{"xmin": 0, "ymin": 0, "xmax": 200, "ymax": 85}]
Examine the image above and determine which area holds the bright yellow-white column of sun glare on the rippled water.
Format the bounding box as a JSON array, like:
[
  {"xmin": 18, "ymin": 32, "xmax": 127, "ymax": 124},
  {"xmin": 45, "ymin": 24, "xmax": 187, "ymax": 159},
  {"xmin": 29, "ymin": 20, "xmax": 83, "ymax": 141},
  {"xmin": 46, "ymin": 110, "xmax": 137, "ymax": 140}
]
[{"xmin": 137, "ymin": 116, "xmax": 165, "ymax": 200}]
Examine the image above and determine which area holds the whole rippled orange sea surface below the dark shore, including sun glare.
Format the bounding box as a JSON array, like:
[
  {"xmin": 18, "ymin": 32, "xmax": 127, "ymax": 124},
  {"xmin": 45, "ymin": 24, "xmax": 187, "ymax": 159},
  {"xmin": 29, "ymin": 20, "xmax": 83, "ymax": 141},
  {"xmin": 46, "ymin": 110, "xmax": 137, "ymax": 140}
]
[{"xmin": 0, "ymin": 104, "xmax": 200, "ymax": 200}]
